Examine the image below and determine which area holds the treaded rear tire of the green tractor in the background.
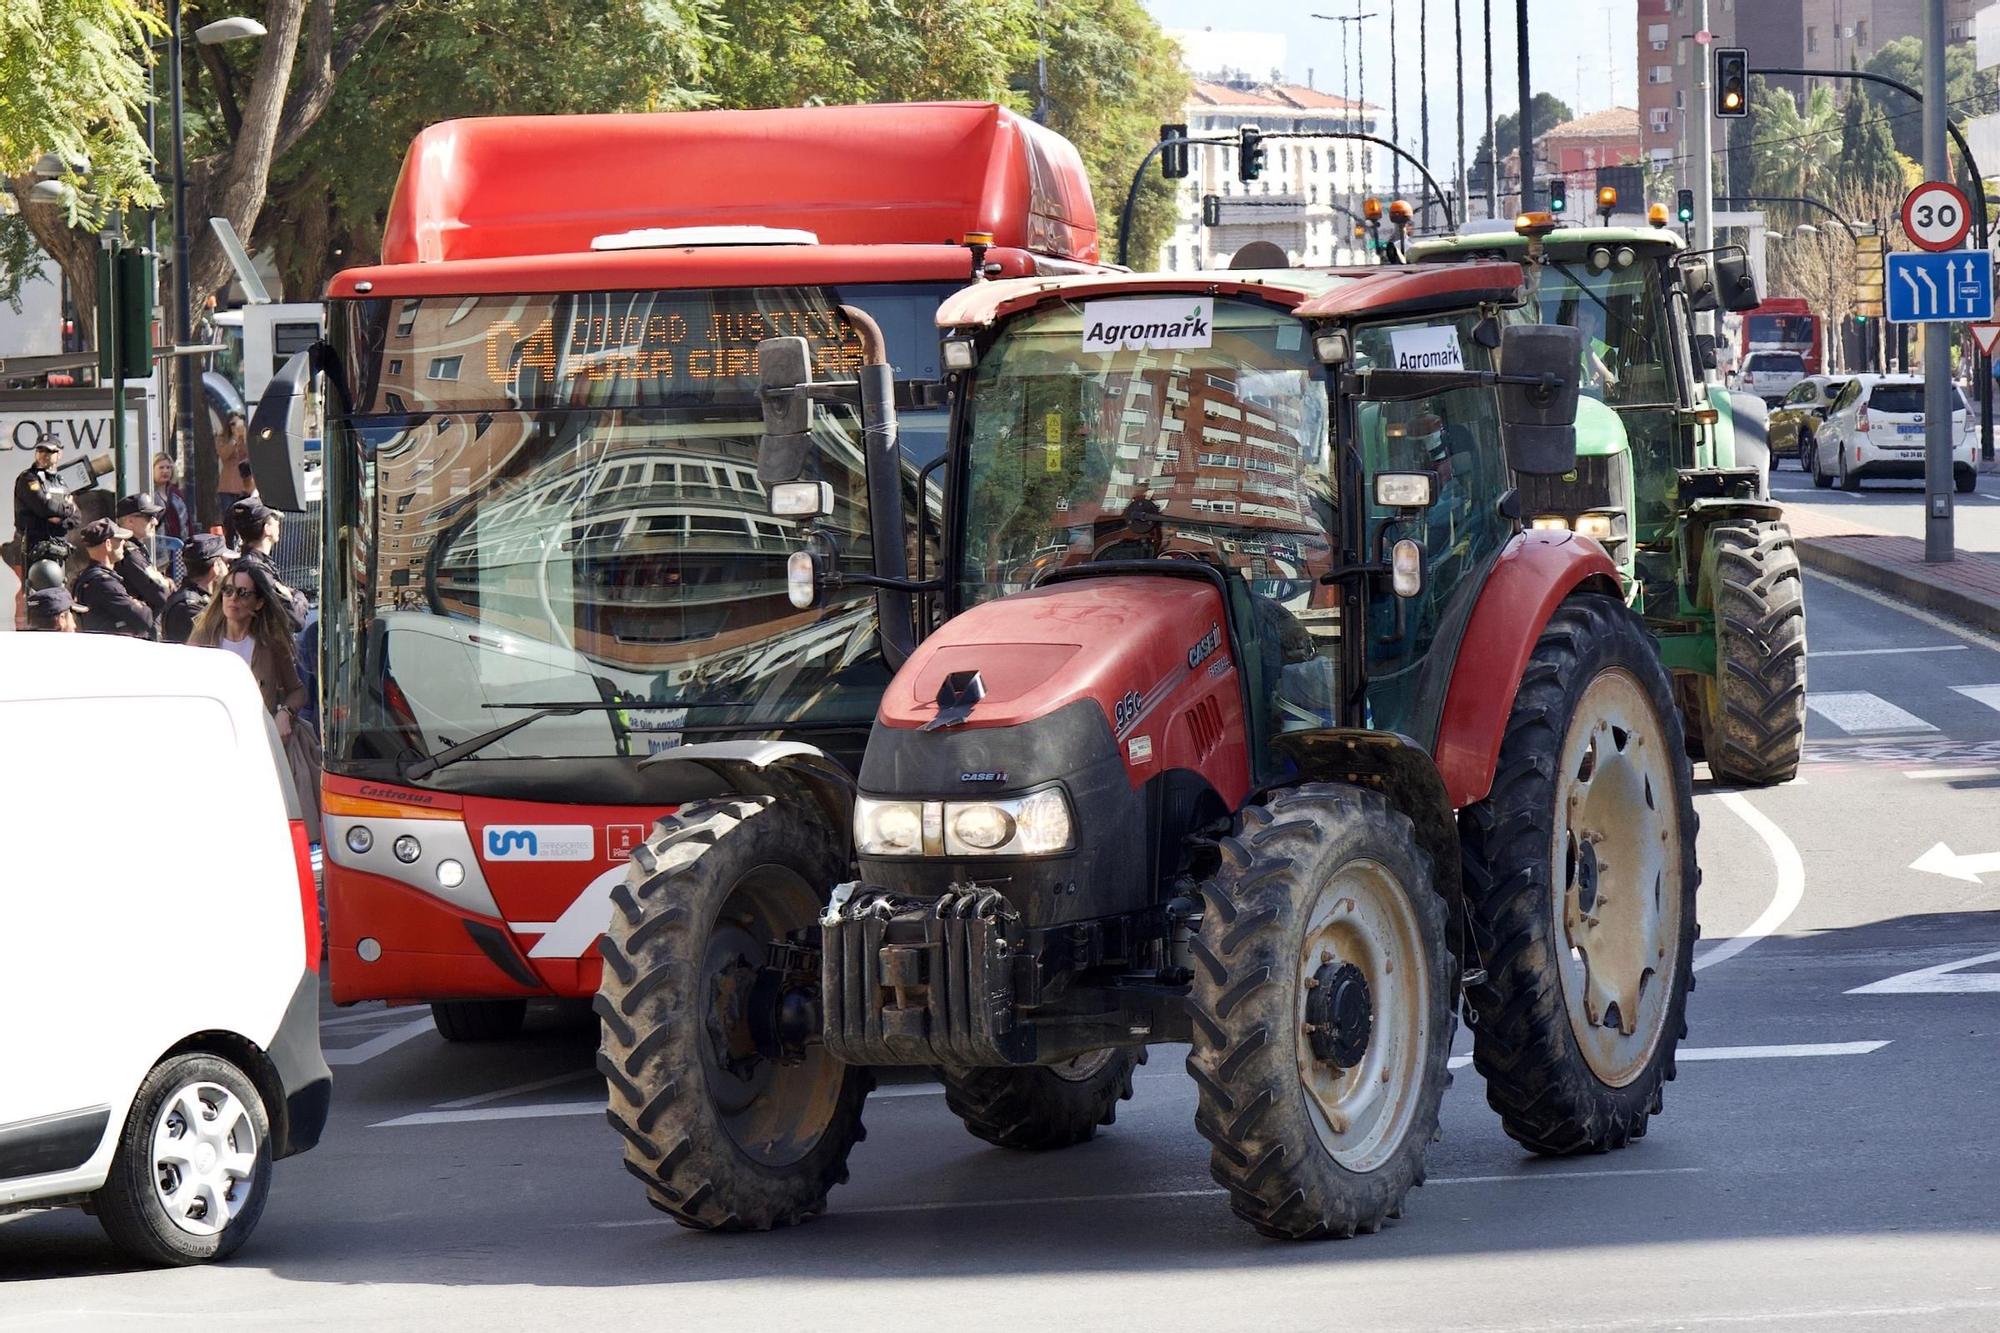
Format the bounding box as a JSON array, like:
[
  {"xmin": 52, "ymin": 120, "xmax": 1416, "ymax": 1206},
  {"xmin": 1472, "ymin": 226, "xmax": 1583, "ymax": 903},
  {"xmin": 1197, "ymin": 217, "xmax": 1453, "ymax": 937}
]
[{"xmin": 1702, "ymin": 520, "xmax": 1806, "ymax": 787}]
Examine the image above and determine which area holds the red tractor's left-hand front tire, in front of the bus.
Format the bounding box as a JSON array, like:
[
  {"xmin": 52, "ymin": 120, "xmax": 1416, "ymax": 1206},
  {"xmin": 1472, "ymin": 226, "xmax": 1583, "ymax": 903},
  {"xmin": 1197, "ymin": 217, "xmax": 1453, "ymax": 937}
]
[{"xmin": 592, "ymin": 797, "xmax": 874, "ymax": 1231}]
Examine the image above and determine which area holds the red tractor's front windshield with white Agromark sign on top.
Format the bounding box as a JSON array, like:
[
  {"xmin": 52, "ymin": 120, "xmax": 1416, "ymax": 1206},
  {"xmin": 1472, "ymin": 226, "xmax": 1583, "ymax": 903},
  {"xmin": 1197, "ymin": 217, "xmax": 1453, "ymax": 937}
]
[{"xmin": 956, "ymin": 296, "xmax": 1340, "ymax": 725}]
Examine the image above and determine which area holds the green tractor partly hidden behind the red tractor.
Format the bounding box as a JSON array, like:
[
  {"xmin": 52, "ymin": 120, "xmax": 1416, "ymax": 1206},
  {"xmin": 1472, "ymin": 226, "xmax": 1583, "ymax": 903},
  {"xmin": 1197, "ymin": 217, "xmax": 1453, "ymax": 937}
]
[{"xmin": 1410, "ymin": 214, "xmax": 1806, "ymax": 787}]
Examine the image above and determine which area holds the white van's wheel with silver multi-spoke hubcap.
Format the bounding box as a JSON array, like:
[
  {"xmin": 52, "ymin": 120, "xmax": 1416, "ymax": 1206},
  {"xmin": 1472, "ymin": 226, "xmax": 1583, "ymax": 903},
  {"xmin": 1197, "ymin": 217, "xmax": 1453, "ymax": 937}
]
[{"xmin": 94, "ymin": 1055, "xmax": 270, "ymax": 1265}]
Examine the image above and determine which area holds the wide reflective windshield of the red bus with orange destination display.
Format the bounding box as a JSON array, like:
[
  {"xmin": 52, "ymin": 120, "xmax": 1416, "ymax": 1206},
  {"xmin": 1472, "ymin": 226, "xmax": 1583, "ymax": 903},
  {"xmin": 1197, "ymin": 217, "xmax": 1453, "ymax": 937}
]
[{"xmin": 324, "ymin": 274, "xmax": 950, "ymax": 784}]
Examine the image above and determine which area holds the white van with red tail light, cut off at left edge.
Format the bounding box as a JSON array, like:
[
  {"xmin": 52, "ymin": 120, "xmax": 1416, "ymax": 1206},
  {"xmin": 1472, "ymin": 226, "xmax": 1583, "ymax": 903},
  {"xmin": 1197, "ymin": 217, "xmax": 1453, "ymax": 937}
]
[{"xmin": 0, "ymin": 632, "xmax": 332, "ymax": 1263}]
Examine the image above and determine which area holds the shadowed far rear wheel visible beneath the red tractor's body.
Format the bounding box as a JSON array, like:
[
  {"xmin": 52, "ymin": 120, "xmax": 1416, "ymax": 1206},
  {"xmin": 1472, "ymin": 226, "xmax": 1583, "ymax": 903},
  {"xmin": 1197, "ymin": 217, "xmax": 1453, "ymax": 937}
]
[{"xmin": 940, "ymin": 1047, "xmax": 1146, "ymax": 1151}]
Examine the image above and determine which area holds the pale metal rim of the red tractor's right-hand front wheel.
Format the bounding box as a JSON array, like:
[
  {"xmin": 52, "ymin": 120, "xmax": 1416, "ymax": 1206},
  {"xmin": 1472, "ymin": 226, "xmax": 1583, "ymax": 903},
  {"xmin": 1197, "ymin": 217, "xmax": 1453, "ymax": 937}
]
[{"xmin": 1296, "ymin": 861, "xmax": 1432, "ymax": 1173}]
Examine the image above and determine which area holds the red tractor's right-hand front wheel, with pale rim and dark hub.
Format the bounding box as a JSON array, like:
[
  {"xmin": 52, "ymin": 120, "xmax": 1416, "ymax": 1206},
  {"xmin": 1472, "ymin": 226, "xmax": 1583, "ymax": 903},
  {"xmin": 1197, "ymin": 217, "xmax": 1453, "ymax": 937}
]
[{"xmin": 1188, "ymin": 785, "xmax": 1458, "ymax": 1241}]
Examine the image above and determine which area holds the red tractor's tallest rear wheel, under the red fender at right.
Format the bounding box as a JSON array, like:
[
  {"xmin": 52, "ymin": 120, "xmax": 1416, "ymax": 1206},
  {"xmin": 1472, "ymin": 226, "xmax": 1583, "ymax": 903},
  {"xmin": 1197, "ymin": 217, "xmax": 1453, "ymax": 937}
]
[{"xmin": 1460, "ymin": 594, "xmax": 1714, "ymax": 1155}]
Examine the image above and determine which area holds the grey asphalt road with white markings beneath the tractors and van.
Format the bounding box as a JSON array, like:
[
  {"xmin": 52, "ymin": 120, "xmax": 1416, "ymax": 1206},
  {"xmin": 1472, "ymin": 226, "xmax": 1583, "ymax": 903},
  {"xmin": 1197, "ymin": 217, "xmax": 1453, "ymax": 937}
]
[{"xmin": 0, "ymin": 578, "xmax": 2000, "ymax": 1331}]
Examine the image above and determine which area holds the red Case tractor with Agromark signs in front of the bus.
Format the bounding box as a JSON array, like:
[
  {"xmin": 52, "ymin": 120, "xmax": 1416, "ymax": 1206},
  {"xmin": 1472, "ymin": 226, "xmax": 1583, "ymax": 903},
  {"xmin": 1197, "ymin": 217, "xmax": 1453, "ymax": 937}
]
[{"xmin": 596, "ymin": 262, "xmax": 1698, "ymax": 1239}]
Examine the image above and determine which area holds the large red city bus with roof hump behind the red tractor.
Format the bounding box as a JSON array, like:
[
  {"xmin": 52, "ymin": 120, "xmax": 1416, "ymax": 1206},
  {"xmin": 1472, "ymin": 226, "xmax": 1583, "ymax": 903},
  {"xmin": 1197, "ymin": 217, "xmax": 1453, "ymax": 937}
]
[{"xmin": 308, "ymin": 104, "xmax": 1098, "ymax": 1039}]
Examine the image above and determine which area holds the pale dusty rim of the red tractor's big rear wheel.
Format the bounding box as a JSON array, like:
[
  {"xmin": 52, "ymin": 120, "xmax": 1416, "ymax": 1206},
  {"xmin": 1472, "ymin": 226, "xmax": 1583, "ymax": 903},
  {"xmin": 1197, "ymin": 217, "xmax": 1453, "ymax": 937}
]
[{"xmin": 1550, "ymin": 671, "xmax": 1682, "ymax": 1087}]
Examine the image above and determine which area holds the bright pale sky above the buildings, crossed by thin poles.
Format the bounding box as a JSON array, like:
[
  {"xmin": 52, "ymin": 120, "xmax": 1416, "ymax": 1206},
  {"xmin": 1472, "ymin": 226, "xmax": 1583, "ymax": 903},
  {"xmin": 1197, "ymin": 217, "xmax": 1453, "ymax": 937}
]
[{"xmin": 1144, "ymin": 0, "xmax": 1638, "ymax": 184}]
